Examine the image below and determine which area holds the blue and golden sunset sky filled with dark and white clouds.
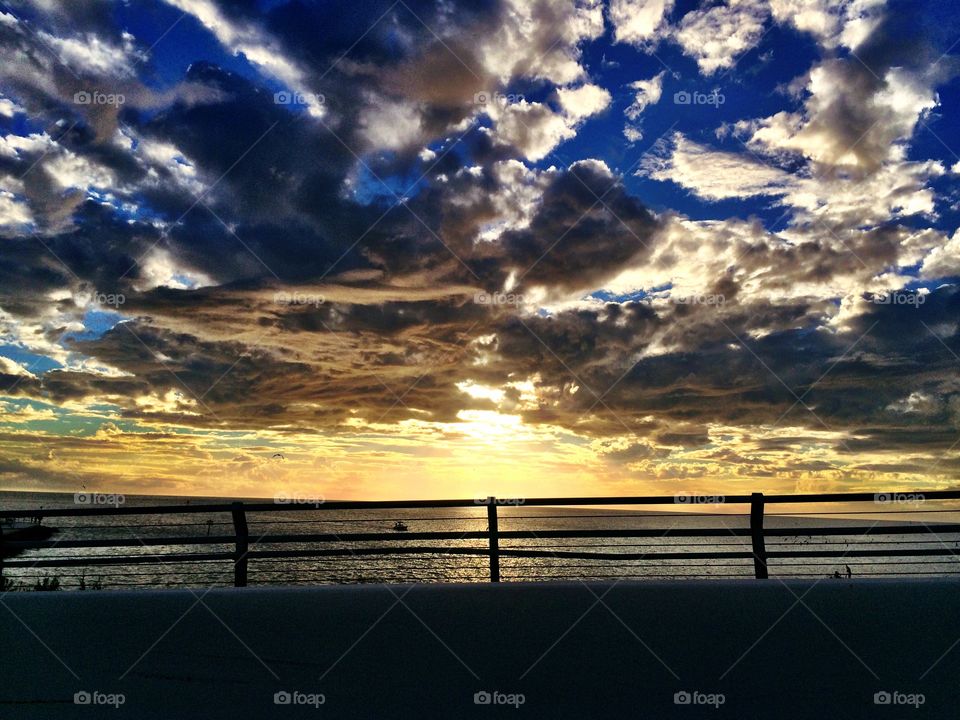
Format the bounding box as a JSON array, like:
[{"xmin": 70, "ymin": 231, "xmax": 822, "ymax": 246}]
[{"xmin": 0, "ymin": 0, "xmax": 960, "ymax": 499}]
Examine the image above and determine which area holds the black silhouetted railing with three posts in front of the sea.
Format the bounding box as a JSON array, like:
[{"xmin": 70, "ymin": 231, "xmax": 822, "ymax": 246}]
[{"xmin": 0, "ymin": 490, "xmax": 960, "ymax": 587}]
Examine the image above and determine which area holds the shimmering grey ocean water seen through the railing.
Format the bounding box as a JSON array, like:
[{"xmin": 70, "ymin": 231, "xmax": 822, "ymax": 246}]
[{"xmin": 0, "ymin": 492, "xmax": 960, "ymax": 590}]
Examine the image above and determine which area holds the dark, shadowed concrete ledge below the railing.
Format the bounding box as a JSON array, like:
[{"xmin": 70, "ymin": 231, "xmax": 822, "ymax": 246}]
[{"xmin": 0, "ymin": 579, "xmax": 960, "ymax": 720}]
